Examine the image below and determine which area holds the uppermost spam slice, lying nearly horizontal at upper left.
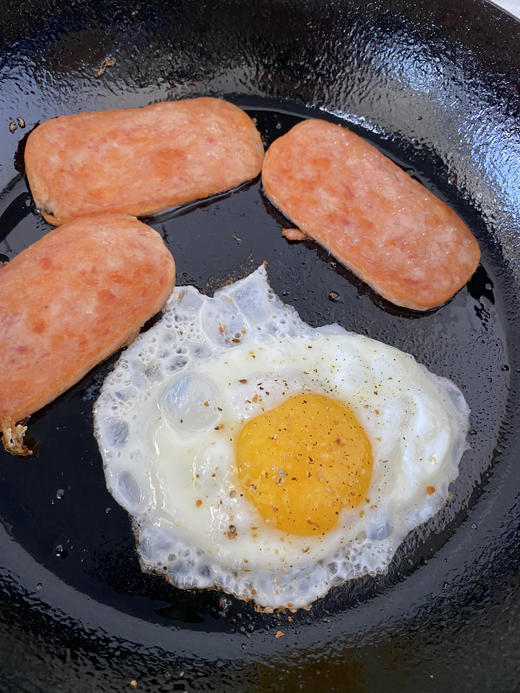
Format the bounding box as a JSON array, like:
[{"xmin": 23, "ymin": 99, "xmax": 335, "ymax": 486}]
[{"xmin": 25, "ymin": 98, "xmax": 264, "ymax": 224}]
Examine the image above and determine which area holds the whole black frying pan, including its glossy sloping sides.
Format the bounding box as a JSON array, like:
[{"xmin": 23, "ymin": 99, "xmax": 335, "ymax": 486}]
[{"xmin": 0, "ymin": 0, "xmax": 520, "ymax": 692}]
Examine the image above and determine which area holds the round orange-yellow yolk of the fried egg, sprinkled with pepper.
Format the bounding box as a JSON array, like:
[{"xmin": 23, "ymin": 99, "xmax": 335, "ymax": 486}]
[{"xmin": 237, "ymin": 393, "xmax": 372, "ymax": 535}]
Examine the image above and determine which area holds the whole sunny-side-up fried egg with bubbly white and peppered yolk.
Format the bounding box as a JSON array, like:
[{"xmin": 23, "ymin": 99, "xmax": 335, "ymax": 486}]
[{"xmin": 94, "ymin": 266, "xmax": 469, "ymax": 609}]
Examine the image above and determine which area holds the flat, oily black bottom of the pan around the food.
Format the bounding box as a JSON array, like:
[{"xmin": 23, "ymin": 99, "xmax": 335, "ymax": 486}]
[{"xmin": 1, "ymin": 104, "xmax": 510, "ymax": 633}]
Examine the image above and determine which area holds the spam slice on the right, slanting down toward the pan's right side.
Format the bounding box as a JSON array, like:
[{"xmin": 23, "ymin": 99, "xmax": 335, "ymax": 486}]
[{"xmin": 262, "ymin": 120, "xmax": 480, "ymax": 310}]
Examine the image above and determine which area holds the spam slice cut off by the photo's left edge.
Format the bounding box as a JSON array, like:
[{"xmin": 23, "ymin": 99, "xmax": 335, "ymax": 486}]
[{"xmin": 0, "ymin": 214, "xmax": 175, "ymax": 455}]
